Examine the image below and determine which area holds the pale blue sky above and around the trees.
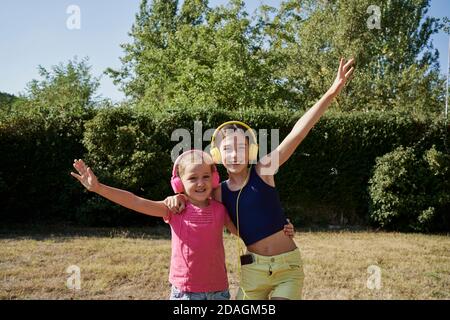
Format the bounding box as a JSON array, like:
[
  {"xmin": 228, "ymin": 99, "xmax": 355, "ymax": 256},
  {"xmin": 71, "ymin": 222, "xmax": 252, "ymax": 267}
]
[{"xmin": 0, "ymin": 0, "xmax": 450, "ymax": 101}]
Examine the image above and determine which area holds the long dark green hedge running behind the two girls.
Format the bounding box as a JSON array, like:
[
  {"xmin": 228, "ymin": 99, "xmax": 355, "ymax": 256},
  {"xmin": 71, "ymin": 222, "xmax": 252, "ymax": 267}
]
[{"xmin": 0, "ymin": 107, "xmax": 449, "ymax": 226}]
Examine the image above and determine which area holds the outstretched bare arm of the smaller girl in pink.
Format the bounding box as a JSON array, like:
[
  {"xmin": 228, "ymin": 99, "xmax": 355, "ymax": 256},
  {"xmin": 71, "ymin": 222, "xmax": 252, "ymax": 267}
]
[{"xmin": 70, "ymin": 160, "xmax": 168, "ymax": 217}]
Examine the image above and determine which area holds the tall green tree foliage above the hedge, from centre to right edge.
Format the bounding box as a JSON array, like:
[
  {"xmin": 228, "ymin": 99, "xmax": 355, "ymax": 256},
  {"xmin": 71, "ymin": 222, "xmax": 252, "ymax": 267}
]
[{"xmin": 108, "ymin": 0, "xmax": 444, "ymax": 112}]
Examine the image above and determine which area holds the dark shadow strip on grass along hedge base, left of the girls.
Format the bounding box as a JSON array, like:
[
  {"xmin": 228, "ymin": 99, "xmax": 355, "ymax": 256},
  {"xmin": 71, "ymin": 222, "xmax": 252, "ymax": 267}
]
[{"xmin": 0, "ymin": 225, "xmax": 170, "ymax": 242}]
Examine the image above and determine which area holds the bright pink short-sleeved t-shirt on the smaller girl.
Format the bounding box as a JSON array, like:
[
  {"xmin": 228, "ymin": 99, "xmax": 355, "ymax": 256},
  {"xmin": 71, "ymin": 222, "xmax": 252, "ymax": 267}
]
[{"xmin": 164, "ymin": 200, "xmax": 230, "ymax": 292}]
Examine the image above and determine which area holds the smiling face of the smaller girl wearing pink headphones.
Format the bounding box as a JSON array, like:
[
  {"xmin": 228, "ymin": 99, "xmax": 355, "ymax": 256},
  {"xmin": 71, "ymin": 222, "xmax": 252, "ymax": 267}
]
[{"xmin": 180, "ymin": 162, "xmax": 212, "ymax": 206}]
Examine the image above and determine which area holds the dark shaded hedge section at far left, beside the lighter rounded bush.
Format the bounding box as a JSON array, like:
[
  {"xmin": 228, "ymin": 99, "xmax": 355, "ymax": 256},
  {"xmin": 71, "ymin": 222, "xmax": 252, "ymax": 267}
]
[{"xmin": 0, "ymin": 115, "xmax": 92, "ymax": 223}]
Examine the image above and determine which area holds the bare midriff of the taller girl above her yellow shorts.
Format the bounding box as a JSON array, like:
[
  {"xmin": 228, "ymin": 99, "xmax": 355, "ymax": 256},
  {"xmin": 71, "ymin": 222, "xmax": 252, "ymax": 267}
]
[{"xmin": 247, "ymin": 230, "xmax": 297, "ymax": 256}]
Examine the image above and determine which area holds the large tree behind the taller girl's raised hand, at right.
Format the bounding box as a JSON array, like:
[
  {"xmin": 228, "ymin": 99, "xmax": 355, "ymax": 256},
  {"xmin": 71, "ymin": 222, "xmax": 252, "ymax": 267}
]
[{"xmin": 268, "ymin": 0, "xmax": 443, "ymax": 112}]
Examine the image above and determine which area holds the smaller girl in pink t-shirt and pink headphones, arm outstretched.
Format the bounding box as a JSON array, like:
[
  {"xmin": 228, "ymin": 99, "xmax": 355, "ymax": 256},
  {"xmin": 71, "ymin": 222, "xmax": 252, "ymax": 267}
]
[{"xmin": 71, "ymin": 150, "xmax": 291, "ymax": 300}]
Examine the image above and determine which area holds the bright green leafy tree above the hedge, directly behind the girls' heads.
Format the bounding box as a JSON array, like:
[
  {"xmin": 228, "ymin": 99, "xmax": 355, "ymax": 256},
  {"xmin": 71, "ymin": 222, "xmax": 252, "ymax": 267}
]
[{"xmin": 108, "ymin": 0, "xmax": 294, "ymax": 109}]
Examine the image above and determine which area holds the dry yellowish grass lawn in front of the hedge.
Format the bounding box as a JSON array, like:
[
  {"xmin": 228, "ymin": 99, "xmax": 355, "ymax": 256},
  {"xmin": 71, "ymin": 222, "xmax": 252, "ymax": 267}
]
[{"xmin": 0, "ymin": 227, "xmax": 450, "ymax": 299}]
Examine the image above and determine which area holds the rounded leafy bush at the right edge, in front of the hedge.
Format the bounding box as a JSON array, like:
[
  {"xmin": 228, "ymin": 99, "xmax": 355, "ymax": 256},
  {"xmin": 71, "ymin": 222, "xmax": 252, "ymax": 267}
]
[{"xmin": 369, "ymin": 146, "xmax": 450, "ymax": 231}]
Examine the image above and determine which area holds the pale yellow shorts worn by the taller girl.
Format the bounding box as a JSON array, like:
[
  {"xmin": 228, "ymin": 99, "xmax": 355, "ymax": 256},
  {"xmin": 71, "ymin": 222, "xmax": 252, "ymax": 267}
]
[{"xmin": 236, "ymin": 248, "xmax": 304, "ymax": 300}]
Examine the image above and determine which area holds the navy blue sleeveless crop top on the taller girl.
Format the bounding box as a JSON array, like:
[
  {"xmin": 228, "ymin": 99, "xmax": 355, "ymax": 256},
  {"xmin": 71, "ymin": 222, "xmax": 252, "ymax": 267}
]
[{"xmin": 221, "ymin": 166, "xmax": 287, "ymax": 246}]
